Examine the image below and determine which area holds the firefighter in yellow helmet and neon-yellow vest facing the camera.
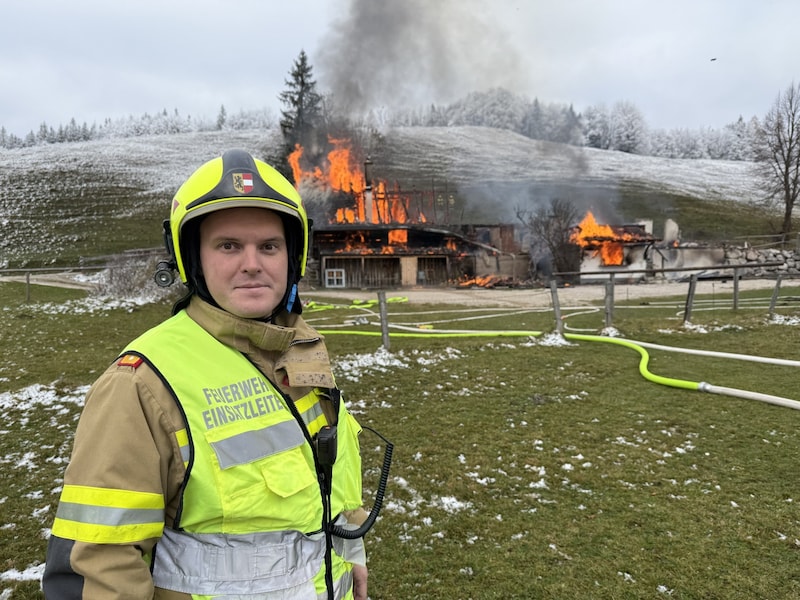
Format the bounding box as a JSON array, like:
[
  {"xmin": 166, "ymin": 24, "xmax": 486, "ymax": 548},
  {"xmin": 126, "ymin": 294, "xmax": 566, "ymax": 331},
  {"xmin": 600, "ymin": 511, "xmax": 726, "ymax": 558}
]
[{"xmin": 42, "ymin": 150, "xmax": 367, "ymax": 600}]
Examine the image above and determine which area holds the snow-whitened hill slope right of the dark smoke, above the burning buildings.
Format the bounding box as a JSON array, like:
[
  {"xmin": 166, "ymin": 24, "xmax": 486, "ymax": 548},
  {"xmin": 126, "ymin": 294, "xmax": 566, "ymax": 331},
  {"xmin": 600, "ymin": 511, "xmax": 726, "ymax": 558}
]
[{"xmin": 374, "ymin": 127, "xmax": 763, "ymax": 216}]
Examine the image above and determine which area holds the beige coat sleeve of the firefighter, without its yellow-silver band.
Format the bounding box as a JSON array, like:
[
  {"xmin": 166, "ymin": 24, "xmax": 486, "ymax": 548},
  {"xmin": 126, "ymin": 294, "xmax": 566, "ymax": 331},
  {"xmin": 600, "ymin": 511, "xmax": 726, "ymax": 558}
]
[{"xmin": 45, "ymin": 354, "xmax": 191, "ymax": 600}]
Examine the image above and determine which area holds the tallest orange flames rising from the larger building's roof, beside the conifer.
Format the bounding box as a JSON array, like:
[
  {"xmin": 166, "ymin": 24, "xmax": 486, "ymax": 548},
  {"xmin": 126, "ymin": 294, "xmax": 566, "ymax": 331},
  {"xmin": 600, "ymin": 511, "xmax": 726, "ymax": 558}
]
[{"xmin": 288, "ymin": 138, "xmax": 427, "ymax": 224}]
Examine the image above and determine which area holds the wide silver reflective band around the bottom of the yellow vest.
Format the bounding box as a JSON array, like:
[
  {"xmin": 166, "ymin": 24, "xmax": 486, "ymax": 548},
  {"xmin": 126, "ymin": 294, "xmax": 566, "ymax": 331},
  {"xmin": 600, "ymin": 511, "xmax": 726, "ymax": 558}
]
[{"xmin": 153, "ymin": 528, "xmax": 324, "ymax": 600}]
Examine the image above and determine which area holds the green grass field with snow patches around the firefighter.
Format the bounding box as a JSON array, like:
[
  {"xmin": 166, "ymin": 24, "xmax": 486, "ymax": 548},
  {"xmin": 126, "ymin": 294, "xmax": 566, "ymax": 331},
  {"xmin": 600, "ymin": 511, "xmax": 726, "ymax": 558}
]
[{"xmin": 0, "ymin": 283, "xmax": 800, "ymax": 600}]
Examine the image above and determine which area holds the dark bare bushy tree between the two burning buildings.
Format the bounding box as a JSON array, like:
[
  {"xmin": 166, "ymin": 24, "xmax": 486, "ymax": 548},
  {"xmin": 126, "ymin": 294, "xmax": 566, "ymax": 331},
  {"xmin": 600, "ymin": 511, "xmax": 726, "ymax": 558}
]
[{"xmin": 516, "ymin": 198, "xmax": 580, "ymax": 280}]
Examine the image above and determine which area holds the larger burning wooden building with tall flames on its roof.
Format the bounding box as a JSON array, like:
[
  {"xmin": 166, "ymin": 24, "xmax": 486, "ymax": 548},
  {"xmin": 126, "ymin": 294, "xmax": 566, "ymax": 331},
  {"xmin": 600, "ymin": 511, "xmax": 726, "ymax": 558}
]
[{"xmin": 289, "ymin": 140, "xmax": 527, "ymax": 288}]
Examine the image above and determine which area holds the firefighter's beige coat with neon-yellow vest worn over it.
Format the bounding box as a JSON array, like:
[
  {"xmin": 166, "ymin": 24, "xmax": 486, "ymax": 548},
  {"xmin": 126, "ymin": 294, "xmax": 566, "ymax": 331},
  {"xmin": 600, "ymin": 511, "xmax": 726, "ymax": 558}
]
[{"xmin": 43, "ymin": 299, "xmax": 365, "ymax": 598}]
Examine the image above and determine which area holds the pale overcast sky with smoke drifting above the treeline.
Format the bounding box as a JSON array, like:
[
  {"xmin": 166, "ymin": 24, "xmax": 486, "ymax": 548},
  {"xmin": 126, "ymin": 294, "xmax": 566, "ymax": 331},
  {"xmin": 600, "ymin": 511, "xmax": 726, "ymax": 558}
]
[{"xmin": 0, "ymin": 0, "xmax": 800, "ymax": 136}]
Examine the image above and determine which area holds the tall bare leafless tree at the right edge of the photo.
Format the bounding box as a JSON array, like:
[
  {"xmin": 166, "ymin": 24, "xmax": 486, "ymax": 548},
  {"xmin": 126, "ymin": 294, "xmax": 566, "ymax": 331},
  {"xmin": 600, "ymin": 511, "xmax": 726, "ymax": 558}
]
[{"xmin": 755, "ymin": 83, "xmax": 800, "ymax": 234}]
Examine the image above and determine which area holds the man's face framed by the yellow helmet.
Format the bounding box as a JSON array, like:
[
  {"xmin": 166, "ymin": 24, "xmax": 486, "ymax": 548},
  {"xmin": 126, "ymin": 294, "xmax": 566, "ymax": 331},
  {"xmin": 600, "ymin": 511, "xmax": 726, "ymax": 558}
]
[{"xmin": 200, "ymin": 207, "xmax": 289, "ymax": 319}]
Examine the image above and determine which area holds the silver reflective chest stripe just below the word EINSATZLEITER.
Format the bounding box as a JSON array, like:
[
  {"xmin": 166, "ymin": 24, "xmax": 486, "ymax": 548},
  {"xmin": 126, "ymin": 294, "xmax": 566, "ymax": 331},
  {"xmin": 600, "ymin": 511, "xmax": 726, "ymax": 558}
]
[{"xmin": 211, "ymin": 421, "xmax": 305, "ymax": 469}]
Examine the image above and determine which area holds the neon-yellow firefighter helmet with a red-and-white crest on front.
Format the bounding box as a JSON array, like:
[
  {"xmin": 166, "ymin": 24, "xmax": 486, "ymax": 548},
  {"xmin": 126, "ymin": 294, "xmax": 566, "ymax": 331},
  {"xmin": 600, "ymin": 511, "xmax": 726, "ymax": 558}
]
[{"xmin": 164, "ymin": 150, "xmax": 309, "ymax": 310}]
